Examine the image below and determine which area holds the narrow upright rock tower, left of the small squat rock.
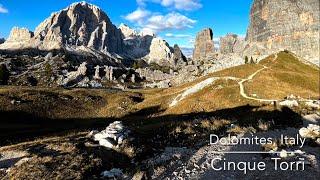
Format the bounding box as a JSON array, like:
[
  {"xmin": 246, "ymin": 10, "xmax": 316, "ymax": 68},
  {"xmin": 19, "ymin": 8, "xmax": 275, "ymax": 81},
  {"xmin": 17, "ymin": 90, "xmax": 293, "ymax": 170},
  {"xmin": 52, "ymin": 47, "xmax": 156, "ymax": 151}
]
[{"xmin": 193, "ymin": 28, "xmax": 214, "ymax": 60}]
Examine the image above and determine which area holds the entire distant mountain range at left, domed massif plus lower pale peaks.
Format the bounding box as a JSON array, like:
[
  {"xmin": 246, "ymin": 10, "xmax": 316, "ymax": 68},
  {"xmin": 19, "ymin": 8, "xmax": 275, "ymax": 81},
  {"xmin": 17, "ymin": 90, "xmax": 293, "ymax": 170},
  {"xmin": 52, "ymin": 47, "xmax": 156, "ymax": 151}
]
[{"xmin": 0, "ymin": 2, "xmax": 185, "ymax": 66}]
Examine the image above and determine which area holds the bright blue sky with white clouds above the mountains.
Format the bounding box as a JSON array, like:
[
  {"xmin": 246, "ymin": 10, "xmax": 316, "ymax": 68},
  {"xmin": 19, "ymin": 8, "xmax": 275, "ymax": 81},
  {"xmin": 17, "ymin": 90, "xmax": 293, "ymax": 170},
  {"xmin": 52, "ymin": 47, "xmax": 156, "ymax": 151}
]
[{"xmin": 0, "ymin": 0, "xmax": 252, "ymax": 47}]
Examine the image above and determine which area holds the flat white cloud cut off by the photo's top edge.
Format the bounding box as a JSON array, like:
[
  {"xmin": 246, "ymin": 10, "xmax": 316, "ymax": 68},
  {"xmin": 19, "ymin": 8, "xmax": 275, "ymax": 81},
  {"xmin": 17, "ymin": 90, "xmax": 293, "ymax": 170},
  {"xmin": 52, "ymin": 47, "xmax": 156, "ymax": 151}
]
[{"xmin": 136, "ymin": 0, "xmax": 202, "ymax": 11}]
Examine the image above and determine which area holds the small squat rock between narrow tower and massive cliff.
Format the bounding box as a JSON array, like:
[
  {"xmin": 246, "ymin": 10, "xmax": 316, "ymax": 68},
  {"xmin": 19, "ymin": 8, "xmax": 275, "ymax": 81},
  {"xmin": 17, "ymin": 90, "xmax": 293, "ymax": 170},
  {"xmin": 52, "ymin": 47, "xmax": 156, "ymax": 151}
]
[{"xmin": 220, "ymin": 34, "xmax": 245, "ymax": 54}]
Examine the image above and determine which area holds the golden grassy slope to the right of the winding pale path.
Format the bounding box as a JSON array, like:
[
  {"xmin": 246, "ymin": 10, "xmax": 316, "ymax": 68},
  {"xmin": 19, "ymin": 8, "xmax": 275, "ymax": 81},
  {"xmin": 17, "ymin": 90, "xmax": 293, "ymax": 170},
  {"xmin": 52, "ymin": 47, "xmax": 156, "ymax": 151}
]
[{"xmin": 245, "ymin": 52, "xmax": 320, "ymax": 99}]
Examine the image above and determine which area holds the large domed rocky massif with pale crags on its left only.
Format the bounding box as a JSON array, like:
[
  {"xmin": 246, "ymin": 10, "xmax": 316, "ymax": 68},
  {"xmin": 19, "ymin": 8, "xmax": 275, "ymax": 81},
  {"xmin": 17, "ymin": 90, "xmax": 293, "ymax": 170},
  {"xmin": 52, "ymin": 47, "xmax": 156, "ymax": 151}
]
[{"xmin": 0, "ymin": 2, "xmax": 123, "ymax": 53}]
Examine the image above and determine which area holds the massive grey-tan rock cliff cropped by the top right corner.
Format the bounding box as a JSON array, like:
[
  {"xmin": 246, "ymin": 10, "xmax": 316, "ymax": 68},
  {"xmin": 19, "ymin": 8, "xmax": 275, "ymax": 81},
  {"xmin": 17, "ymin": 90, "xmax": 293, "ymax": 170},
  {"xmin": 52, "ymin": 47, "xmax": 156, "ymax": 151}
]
[{"xmin": 246, "ymin": 0, "xmax": 320, "ymax": 63}]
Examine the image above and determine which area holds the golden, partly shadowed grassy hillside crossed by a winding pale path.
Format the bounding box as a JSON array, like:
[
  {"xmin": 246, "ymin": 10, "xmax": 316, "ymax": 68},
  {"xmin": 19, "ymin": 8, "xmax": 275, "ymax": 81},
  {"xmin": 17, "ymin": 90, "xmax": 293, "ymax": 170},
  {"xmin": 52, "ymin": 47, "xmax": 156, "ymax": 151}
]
[{"xmin": 0, "ymin": 52, "xmax": 319, "ymax": 179}]
